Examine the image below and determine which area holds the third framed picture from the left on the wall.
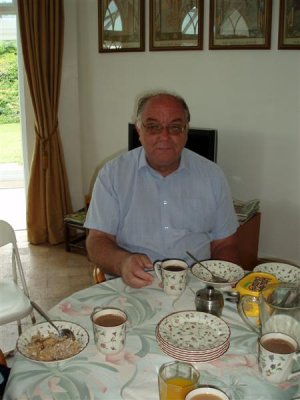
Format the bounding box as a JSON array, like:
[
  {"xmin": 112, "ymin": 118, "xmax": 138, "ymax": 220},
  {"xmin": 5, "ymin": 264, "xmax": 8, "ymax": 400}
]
[{"xmin": 209, "ymin": 0, "xmax": 272, "ymax": 50}]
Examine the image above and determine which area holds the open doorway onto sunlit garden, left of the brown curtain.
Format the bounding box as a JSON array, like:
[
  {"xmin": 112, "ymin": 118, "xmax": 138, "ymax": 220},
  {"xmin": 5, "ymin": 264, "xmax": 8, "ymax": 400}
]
[{"xmin": 0, "ymin": 0, "xmax": 26, "ymax": 230}]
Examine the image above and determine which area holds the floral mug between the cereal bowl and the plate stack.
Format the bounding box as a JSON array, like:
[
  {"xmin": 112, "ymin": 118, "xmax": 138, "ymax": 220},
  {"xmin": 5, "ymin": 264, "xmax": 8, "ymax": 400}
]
[{"xmin": 91, "ymin": 307, "xmax": 127, "ymax": 354}]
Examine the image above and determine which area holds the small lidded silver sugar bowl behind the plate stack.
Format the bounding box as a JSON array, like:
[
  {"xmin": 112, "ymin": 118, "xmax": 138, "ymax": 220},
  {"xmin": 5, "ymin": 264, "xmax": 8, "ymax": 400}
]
[{"xmin": 195, "ymin": 286, "xmax": 224, "ymax": 317}]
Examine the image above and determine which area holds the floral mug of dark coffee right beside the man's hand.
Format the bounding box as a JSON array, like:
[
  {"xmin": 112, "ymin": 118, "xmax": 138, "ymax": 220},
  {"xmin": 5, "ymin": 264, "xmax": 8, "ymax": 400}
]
[{"xmin": 154, "ymin": 259, "xmax": 188, "ymax": 296}]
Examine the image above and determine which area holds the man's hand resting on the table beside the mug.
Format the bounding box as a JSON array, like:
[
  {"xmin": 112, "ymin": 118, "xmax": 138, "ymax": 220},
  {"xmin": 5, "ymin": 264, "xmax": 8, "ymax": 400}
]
[{"xmin": 120, "ymin": 253, "xmax": 154, "ymax": 288}]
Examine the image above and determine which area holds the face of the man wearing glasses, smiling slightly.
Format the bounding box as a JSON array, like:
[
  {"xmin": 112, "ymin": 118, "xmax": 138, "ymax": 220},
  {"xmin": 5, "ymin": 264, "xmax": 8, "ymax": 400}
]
[{"xmin": 137, "ymin": 95, "xmax": 188, "ymax": 176}]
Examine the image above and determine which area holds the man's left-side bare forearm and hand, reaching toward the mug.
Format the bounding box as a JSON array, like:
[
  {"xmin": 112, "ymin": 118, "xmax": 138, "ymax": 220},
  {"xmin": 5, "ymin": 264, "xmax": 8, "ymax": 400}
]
[{"xmin": 86, "ymin": 229, "xmax": 153, "ymax": 288}]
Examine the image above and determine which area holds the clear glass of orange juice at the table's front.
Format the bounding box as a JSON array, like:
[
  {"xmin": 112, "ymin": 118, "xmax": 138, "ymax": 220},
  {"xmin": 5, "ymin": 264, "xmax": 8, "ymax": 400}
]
[{"xmin": 158, "ymin": 361, "xmax": 200, "ymax": 400}]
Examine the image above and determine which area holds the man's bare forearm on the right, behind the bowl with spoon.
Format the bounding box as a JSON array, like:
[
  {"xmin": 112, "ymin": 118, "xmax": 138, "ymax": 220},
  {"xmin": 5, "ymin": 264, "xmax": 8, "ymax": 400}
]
[{"xmin": 210, "ymin": 233, "xmax": 240, "ymax": 265}]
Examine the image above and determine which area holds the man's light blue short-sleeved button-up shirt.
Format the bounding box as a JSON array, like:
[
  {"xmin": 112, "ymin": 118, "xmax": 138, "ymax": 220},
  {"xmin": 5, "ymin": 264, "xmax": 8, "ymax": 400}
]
[{"xmin": 85, "ymin": 147, "xmax": 238, "ymax": 264}]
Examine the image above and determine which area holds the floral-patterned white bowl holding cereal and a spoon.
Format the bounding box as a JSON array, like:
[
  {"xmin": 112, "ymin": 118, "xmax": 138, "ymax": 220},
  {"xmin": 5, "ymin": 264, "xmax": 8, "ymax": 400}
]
[{"xmin": 17, "ymin": 321, "xmax": 89, "ymax": 364}]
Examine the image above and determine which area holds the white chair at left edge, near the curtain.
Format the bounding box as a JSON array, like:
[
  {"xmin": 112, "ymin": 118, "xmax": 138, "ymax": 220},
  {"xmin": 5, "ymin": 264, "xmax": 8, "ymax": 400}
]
[{"xmin": 0, "ymin": 220, "xmax": 36, "ymax": 335}]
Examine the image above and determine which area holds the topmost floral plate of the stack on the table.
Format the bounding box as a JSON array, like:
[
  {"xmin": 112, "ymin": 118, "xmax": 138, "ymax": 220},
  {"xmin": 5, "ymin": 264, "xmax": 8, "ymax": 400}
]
[{"xmin": 157, "ymin": 310, "xmax": 230, "ymax": 352}]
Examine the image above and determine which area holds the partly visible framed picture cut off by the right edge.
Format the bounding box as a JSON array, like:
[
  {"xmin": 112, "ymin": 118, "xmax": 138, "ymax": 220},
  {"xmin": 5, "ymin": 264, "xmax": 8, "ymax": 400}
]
[{"xmin": 278, "ymin": 0, "xmax": 300, "ymax": 50}]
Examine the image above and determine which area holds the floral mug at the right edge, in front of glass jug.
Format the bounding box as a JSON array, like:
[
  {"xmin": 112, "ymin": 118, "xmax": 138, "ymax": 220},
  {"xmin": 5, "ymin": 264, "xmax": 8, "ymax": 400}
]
[{"xmin": 258, "ymin": 332, "xmax": 300, "ymax": 383}]
